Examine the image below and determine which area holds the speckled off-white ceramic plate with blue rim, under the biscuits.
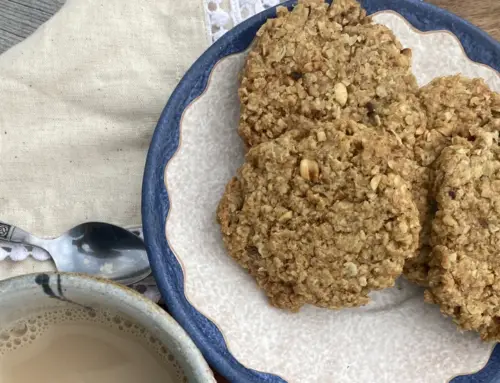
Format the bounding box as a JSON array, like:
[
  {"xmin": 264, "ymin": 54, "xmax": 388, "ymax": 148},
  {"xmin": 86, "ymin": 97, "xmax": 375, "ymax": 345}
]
[{"xmin": 143, "ymin": 0, "xmax": 500, "ymax": 383}]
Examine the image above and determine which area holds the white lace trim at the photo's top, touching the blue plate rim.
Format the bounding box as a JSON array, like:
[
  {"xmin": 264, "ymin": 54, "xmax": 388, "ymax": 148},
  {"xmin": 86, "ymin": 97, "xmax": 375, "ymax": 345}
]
[{"xmin": 204, "ymin": 0, "xmax": 285, "ymax": 42}]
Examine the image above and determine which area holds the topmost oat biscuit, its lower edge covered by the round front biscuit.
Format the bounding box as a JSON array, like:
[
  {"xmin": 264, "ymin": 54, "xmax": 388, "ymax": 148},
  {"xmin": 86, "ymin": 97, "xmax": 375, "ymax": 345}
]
[{"xmin": 239, "ymin": 0, "xmax": 418, "ymax": 147}]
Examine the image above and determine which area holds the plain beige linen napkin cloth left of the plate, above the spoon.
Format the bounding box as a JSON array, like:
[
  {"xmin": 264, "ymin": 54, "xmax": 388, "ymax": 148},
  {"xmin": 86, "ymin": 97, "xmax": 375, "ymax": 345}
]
[{"xmin": 0, "ymin": 0, "xmax": 209, "ymax": 279}]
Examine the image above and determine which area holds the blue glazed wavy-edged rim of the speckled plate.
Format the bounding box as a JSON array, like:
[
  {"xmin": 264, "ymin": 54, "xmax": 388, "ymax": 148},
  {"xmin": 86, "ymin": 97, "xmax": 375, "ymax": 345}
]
[{"xmin": 142, "ymin": 0, "xmax": 500, "ymax": 383}]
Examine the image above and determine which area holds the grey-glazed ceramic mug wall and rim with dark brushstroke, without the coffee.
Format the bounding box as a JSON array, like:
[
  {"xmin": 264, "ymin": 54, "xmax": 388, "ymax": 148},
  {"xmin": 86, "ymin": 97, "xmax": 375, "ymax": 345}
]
[{"xmin": 0, "ymin": 273, "xmax": 215, "ymax": 383}]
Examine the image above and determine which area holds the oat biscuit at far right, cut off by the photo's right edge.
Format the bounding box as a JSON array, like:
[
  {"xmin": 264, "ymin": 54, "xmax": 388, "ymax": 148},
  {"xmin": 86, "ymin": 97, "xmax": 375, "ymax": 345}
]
[{"xmin": 425, "ymin": 130, "xmax": 500, "ymax": 340}]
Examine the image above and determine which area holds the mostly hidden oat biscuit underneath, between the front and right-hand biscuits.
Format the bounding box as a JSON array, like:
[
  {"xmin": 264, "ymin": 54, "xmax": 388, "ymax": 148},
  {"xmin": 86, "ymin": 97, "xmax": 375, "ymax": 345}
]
[{"xmin": 404, "ymin": 75, "xmax": 500, "ymax": 286}]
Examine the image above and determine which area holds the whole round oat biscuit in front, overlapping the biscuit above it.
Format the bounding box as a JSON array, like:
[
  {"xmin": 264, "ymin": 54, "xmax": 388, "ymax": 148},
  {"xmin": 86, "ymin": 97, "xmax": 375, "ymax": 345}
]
[{"xmin": 217, "ymin": 121, "xmax": 420, "ymax": 311}]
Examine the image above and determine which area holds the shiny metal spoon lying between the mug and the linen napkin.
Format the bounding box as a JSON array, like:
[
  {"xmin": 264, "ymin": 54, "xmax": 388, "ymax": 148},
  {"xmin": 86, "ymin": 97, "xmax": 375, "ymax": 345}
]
[{"xmin": 0, "ymin": 222, "xmax": 151, "ymax": 285}]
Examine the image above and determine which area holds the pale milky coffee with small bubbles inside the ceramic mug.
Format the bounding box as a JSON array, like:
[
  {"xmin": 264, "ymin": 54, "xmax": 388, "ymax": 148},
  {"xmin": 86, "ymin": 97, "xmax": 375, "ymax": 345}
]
[{"xmin": 0, "ymin": 308, "xmax": 187, "ymax": 383}]
